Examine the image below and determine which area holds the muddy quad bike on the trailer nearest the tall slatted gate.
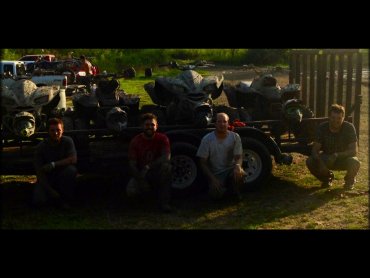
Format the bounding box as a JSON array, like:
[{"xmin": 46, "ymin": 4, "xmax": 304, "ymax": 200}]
[{"xmin": 225, "ymin": 74, "xmax": 314, "ymax": 142}]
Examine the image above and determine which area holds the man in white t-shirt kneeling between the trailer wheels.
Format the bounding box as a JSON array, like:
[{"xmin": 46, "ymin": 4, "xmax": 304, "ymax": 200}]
[{"xmin": 197, "ymin": 113, "xmax": 245, "ymax": 200}]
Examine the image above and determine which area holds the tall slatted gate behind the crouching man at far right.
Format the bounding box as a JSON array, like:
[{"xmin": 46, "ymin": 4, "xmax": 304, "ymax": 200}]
[{"xmin": 289, "ymin": 49, "xmax": 362, "ymax": 136}]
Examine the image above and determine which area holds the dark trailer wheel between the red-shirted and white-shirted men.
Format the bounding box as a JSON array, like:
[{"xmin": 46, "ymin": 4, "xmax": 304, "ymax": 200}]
[{"xmin": 171, "ymin": 142, "xmax": 201, "ymax": 196}]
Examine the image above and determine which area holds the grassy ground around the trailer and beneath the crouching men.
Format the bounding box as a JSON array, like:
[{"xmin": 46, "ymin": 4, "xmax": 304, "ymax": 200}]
[{"xmin": 1, "ymin": 65, "xmax": 369, "ymax": 230}]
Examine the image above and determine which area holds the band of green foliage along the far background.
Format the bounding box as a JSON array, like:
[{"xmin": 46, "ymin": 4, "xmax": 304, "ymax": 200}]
[{"xmin": 2, "ymin": 48, "xmax": 287, "ymax": 72}]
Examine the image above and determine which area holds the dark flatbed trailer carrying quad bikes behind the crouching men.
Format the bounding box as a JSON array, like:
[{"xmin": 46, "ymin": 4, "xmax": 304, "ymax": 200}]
[{"xmin": 1, "ymin": 118, "xmax": 326, "ymax": 193}]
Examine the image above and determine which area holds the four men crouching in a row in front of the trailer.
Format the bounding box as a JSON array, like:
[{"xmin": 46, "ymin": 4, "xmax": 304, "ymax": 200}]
[{"xmin": 33, "ymin": 104, "xmax": 360, "ymax": 212}]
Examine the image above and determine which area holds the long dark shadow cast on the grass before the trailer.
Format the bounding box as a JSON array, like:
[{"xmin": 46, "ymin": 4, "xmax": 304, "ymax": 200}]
[{"xmin": 1, "ymin": 175, "xmax": 364, "ymax": 229}]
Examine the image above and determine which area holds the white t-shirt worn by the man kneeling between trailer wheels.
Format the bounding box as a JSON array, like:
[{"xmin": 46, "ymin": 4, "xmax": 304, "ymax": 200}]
[{"xmin": 197, "ymin": 131, "xmax": 243, "ymax": 174}]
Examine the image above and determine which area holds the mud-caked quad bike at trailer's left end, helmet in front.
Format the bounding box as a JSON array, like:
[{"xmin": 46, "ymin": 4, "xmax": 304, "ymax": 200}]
[{"xmin": 1, "ymin": 78, "xmax": 66, "ymax": 140}]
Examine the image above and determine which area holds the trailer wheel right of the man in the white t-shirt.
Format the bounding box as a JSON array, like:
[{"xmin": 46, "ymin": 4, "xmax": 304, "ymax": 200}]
[{"xmin": 243, "ymin": 137, "xmax": 272, "ymax": 191}]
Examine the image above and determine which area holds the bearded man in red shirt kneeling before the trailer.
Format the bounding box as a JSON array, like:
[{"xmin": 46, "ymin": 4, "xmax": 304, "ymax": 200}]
[{"xmin": 126, "ymin": 113, "xmax": 172, "ymax": 212}]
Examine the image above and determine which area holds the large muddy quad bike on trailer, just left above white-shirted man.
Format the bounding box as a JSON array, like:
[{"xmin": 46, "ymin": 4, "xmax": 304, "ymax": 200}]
[{"xmin": 142, "ymin": 70, "xmax": 224, "ymax": 127}]
